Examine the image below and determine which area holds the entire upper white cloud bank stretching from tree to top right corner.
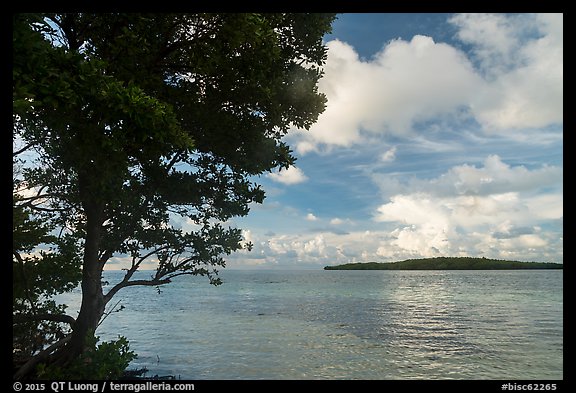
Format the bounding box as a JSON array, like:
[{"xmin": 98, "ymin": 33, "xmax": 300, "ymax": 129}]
[{"xmin": 292, "ymin": 14, "xmax": 563, "ymax": 153}]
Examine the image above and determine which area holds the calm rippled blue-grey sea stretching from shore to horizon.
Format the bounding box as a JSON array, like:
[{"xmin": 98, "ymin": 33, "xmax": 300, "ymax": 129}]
[{"xmin": 59, "ymin": 269, "xmax": 563, "ymax": 380}]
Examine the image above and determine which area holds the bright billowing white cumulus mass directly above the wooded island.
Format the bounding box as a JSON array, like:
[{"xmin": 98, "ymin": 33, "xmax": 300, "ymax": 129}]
[{"xmin": 374, "ymin": 156, "xmax": 563, "ymax": 256}]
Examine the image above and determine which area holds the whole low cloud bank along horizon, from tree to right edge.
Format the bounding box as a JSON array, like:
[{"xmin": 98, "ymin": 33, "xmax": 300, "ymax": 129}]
[{"xmin": 231, "ymin": 155, "xmax": 563, "ymax": 268}]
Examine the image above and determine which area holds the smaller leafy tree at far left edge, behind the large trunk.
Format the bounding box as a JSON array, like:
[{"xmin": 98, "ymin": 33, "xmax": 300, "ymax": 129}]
[{"xmin": 12, "ymin": 181, "xmax": 81, "ymax": 365}]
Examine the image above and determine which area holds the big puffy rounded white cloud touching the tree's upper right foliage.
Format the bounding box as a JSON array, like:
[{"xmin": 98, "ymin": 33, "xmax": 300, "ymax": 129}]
[{"xmin": 296, "ymin": 35, "xmax": 481, "ymax": 154}]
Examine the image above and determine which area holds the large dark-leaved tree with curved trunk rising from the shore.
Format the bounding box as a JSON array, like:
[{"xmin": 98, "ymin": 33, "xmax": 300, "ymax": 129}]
[{"xmin": 13, "ymin": 14, "xmax": 334, "ymax": 378}]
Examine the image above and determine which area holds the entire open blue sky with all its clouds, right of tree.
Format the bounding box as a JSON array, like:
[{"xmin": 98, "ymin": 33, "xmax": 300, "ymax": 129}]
[{"xmin": 219, "ymin": 14, "xmax": 563, "ymax": 268}]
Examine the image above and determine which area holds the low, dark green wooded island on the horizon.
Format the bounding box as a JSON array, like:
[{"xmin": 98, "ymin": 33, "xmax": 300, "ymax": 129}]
[{"xmin": 324, "ymin": 257, "xmax": 564, "ymax": 270}]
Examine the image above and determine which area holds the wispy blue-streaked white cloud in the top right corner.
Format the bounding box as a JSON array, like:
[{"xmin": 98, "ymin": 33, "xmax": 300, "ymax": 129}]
[{"xmin": 450, "ymin": 14, "xmax": 563, "ymax": 130}]
